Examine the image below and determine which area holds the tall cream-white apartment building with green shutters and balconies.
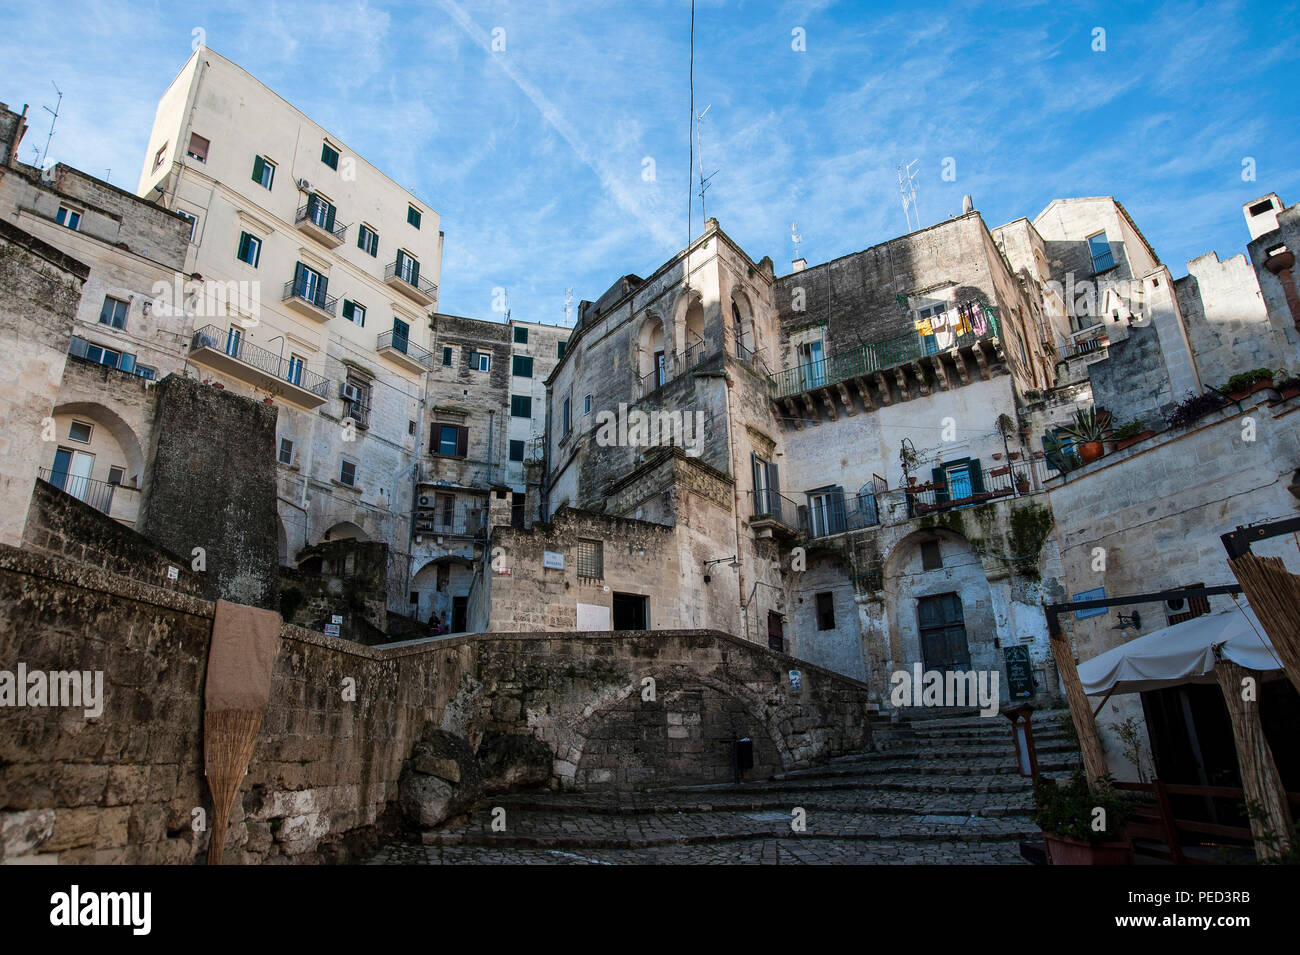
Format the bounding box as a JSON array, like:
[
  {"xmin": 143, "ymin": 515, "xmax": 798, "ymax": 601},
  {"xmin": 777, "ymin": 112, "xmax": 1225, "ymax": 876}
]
[{"xmin": 138, "ymin": 47, "xmax": 443, "ymax": 609}]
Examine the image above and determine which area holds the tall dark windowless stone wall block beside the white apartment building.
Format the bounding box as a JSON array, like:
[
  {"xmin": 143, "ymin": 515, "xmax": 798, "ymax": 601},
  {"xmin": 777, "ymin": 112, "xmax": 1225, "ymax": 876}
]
[{"xmin": 139, "ymin": 374, "xmax": 278, "ymax": 608}]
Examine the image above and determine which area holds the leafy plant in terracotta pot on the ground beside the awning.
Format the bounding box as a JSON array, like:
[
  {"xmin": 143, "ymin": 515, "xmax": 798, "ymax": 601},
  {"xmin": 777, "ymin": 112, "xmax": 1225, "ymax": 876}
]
[{"xmin": 1034, "ymin": 769, "xmax": 1134, "ymax": 865}]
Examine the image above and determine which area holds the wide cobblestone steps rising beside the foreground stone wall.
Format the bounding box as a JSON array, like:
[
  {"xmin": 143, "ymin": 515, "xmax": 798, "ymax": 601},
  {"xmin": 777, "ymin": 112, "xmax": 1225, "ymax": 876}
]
[{"xmin": 368, "ymin": 717, "xmax": 1078, "ymax": 865}]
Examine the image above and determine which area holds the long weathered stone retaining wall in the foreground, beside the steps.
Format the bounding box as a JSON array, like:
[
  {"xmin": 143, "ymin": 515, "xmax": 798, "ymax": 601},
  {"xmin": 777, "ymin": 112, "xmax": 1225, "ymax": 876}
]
[{"xmin": 0, "ymin": 537, "xmax": 870, "ymax": 863}]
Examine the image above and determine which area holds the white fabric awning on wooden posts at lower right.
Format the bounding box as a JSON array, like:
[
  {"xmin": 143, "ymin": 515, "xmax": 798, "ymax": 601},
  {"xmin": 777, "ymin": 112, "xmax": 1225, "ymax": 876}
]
[{"xmin": 1079, "ymin": 604, "xmax": 1282, "ymax": 696}]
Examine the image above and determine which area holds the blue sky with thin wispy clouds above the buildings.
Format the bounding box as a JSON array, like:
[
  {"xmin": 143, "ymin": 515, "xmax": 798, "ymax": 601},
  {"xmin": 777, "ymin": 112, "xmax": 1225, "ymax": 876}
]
[{"xmin": 0, "ymin": 0, "xmax": 1300, "ymax": 322}]
